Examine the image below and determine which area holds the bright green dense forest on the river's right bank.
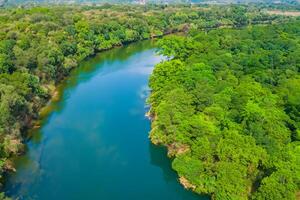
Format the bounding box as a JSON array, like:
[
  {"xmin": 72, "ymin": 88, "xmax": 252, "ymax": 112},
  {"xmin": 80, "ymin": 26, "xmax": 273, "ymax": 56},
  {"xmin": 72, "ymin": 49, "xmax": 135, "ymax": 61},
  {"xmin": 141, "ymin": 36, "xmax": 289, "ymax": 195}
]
[{"xmin": 149, "ymin": 20, "xmax": 300, "ymax": 200}]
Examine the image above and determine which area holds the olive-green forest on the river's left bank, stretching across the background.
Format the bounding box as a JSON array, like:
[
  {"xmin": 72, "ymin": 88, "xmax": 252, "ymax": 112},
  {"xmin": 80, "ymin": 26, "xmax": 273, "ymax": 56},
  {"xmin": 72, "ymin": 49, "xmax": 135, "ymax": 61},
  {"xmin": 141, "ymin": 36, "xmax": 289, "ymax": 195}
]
[{"xmin": 0, "ymin": 4, "xmax": 297, "ymax": 198}]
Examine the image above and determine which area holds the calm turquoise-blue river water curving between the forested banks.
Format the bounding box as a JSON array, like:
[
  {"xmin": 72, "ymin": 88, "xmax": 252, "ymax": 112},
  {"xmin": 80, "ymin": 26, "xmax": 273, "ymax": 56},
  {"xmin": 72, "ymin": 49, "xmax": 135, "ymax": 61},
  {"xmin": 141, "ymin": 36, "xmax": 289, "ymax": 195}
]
[{"xmin": 5, "ymin": 41, "xmax": 205, "ymax": 200}]
